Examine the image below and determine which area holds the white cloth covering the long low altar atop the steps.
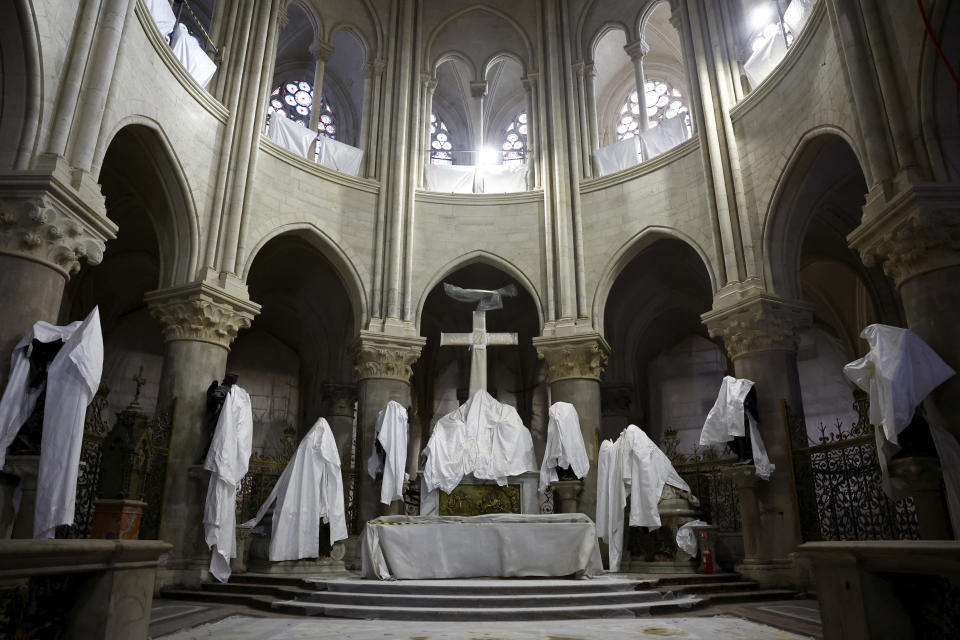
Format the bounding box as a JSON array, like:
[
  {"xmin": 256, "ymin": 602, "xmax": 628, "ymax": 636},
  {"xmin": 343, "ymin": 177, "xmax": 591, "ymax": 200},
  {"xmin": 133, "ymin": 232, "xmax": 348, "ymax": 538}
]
[{"xmin": 361, "ymin": 513, "xmax": 603, "ymax": 580}]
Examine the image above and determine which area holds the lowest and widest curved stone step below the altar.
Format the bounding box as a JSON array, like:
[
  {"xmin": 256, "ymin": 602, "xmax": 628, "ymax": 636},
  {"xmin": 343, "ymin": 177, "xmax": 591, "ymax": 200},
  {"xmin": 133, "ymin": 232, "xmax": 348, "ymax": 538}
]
[{"xmin": 274, "ymin": 596, "xmax": 702, "ymax": 621}]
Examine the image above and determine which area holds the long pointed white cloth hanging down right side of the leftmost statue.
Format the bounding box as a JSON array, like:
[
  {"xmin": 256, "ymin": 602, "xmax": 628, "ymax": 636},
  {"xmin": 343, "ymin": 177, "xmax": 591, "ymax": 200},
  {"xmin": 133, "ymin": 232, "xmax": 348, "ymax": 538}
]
[{"xmin": 33, "ymin": 307, "xmax": 103, "ymax": 538}]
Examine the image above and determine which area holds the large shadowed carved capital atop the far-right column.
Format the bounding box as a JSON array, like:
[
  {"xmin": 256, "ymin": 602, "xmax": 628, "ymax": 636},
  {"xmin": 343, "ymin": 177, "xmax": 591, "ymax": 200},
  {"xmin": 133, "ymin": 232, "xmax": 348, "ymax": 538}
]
[{"xmin": 847, "ymin": 185, "xmax": 960, "ymax": 287}]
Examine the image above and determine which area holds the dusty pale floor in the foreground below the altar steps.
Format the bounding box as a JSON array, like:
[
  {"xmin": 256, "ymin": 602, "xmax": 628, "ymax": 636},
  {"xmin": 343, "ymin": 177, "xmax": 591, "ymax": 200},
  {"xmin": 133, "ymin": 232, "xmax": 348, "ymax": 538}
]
[{"xmin": 150, "ymin": 600, "xmax": 822, "ymax": 640}]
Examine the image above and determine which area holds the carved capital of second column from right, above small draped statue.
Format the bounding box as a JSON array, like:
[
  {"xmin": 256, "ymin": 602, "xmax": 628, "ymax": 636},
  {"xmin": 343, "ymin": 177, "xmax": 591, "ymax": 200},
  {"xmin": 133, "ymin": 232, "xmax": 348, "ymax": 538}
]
[{"xmin": 700, "ymin": 294, "xmax": 813, "ymax": 360}]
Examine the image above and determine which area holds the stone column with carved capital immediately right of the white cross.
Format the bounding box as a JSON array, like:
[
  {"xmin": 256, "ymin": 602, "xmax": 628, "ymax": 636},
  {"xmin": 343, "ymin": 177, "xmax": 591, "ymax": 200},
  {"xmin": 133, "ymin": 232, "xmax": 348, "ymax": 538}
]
[{"xmin": 533, "ymin": 332, "xmax": 610, "ymax": 519}]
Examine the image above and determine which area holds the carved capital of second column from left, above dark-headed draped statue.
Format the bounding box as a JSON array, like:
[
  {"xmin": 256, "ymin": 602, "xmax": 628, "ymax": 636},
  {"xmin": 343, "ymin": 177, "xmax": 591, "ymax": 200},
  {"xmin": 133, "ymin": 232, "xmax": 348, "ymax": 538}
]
[{"xmin": 144, "ymin": 282, "xmax": 260, "ymax": 350}]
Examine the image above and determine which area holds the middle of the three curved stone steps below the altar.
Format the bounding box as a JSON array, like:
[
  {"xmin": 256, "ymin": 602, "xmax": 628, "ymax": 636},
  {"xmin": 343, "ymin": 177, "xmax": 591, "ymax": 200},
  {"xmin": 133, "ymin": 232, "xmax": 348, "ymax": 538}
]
[{"xmin": 296, "ymin": 590, "xmax": 665, "ymax": 609}]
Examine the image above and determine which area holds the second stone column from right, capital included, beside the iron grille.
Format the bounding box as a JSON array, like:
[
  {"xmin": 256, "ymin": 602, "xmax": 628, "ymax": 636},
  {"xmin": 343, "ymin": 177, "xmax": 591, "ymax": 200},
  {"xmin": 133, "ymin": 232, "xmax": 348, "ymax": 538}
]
[{"xmin": 702, "ymin": 290, "xmax": 811, "ymax": 585}]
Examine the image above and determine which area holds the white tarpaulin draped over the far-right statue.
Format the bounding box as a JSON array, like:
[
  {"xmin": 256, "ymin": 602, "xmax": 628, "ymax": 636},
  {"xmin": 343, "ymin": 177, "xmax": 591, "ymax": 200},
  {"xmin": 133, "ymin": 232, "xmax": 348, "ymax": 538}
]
[{"xmin": 843, "ymin": 324, "xmax": 960, "ymax": 531}]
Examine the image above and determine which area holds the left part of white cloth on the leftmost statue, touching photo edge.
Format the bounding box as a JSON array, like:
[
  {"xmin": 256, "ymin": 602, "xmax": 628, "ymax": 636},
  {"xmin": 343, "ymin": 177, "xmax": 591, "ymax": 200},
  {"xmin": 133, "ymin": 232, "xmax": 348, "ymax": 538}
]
[{"xmin": 0, "ymin": 320, "xmax": 81, "ymax": 469}]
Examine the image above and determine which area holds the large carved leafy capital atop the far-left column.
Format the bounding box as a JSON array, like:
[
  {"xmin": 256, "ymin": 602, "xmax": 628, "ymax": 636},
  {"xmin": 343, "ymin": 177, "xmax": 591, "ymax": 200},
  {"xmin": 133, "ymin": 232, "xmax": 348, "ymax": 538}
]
[{"xmin": 0, "ymin": 170, "xmax": 117, "ymax": 278}]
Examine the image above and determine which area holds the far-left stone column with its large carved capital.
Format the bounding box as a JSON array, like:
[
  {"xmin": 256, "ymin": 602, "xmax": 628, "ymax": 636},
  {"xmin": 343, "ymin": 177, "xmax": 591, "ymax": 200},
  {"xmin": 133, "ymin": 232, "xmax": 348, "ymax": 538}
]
[{"xmin": 0, "ymin": 170, "xmax": 117, "ymax": 390}]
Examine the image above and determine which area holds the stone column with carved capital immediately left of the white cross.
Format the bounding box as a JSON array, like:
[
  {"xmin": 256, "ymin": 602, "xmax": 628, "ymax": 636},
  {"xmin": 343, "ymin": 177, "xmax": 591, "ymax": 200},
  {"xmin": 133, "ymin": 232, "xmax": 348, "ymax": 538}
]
[{"xmin": 352, "ymin": 331, "xmax": 426, "ymax": 533}]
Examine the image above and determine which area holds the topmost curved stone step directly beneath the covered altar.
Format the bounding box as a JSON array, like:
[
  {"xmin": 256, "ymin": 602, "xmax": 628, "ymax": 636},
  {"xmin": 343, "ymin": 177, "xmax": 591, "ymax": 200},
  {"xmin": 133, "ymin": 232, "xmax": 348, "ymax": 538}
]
[{"xmin": 305, "ymin": 578, "xmax": 656, "ymax": 596}]
